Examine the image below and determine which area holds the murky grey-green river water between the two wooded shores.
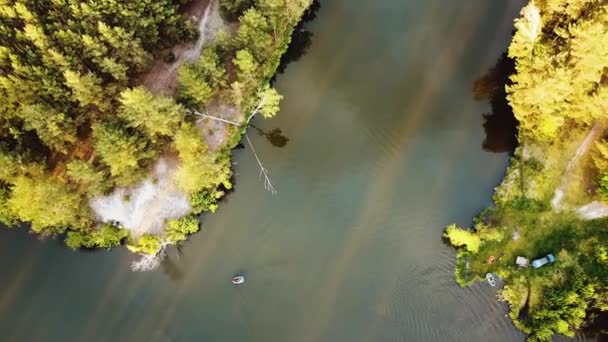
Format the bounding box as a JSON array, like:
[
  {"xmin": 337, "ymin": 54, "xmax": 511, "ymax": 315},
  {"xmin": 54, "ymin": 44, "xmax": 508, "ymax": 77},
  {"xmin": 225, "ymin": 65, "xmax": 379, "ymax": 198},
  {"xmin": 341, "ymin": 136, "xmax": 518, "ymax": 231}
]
[{"xmin": 0, "ymin": 0, "xmax": 568, "ymax": 342}]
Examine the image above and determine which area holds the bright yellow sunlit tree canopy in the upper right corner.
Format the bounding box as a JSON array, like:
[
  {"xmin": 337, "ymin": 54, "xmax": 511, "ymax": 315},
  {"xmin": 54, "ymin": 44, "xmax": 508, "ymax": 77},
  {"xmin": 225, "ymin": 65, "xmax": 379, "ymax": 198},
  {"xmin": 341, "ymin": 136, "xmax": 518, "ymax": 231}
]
[{"xmin": 507, "ymin": 0, "xmax": 608, "ymax": 141}]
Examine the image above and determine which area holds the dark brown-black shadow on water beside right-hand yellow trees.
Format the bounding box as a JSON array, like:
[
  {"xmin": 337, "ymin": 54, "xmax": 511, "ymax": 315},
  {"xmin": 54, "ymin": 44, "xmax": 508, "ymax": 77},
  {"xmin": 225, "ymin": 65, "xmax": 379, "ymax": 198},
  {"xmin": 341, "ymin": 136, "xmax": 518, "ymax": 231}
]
[{"xmin": 473, "ymin": 53, "xmax": 518, "ymax": 155}]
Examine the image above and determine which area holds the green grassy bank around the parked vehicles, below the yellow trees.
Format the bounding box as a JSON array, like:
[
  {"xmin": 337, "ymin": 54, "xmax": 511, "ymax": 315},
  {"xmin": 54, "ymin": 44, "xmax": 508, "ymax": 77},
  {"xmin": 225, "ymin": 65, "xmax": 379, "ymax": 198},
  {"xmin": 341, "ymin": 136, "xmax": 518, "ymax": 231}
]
[{"xmin": 446, "ymin": 122, "xmax": 608, "ymax": 340}]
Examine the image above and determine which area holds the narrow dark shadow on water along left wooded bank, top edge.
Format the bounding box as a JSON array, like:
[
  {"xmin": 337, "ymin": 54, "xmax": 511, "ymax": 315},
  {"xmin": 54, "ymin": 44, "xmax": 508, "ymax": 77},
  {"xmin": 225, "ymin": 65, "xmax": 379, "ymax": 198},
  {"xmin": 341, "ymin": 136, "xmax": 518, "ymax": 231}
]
[{"xmin": 270, "ymin": 0, "xmax": 321, "ymax": 79}]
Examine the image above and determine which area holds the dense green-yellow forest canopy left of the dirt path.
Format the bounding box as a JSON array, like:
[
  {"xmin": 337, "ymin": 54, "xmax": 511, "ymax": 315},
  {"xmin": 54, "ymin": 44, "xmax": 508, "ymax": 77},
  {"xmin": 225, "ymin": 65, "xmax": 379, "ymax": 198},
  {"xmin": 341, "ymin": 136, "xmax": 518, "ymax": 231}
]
[{"xmin": 0, "ymin": 0, "xmax": 196, "ymax": 234}]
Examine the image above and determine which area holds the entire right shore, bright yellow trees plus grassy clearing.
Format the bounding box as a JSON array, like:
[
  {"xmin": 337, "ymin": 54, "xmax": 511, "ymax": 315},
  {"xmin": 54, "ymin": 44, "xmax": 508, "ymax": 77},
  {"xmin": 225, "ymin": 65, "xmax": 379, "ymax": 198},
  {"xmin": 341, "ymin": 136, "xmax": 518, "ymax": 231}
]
[{"xmin": 444, "ymin": 0, "xmax": 608, "ymax": 341}]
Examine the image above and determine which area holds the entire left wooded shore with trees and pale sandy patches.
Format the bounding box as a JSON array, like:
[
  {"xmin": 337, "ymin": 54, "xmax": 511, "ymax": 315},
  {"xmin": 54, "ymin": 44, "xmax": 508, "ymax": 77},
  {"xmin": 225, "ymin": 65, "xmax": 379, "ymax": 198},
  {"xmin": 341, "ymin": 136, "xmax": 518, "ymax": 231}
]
[{"xmin": 0, "ymin": 0, "xmax": 312, "ymax": 270}]
